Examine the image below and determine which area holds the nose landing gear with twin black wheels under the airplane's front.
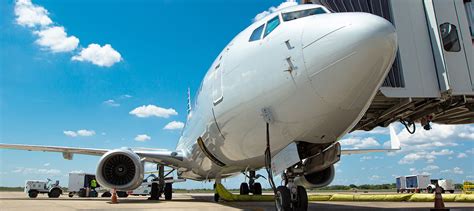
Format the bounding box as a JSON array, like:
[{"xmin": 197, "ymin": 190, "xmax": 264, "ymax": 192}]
[{"xmin": 275, "ymin": 166, "xmax": 308, "ymax": 211}]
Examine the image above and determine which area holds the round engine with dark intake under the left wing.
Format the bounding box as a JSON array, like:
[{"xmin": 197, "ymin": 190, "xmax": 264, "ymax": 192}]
[{"xmin": 96, "ymin": 149, "xmax": 145, "ymax": 190}]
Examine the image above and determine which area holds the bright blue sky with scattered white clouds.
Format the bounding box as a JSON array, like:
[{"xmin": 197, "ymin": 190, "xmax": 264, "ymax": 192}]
[{"xmin": 0, "ymin": 0, "xmax": 474, "ymax": 189}]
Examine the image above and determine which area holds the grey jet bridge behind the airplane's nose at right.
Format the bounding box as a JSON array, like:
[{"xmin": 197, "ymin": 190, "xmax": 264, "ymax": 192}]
[{"xmin": 302, "ymin": 0, "xmax": 474, "ymax": 130}]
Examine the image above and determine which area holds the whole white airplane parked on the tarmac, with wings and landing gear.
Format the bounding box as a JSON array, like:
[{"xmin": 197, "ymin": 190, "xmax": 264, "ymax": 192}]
[{"xmin": 0, "ymin": 5, "xmax": 400, "ymax": 210}]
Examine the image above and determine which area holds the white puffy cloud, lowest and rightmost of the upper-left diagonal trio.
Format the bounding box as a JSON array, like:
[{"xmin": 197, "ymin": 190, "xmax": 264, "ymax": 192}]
[{"xmin": 71, "ymin": 43, "xmax": 122, "ymax": 67}]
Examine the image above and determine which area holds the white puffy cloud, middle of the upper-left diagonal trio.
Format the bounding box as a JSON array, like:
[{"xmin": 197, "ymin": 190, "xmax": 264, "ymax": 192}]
[{"xmin": 34, "ymin": 26, "xmax": 79, "ymax": 53}]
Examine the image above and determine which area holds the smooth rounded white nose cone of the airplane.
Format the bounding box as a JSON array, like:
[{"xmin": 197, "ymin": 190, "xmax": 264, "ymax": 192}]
[{"xmin": 302, "ymin": 13, "xmax": 397, "ymax": 109}]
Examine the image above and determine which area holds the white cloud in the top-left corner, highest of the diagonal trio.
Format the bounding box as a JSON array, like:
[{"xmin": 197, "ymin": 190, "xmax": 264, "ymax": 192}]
[{"xmin": 15, "ymin": 0, "xmax": 53, "ymax": 27}]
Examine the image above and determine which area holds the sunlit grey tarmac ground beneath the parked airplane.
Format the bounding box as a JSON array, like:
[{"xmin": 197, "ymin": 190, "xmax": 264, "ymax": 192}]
[{"xmin": 0, "ymin": 192, "xmax": 474, "ymax": 211}]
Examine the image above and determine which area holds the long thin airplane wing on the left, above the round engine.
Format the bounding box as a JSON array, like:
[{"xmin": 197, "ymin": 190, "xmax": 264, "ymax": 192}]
[{"xmin": 0, "ymin": 143, "xmax": 183, "ymax": 168}]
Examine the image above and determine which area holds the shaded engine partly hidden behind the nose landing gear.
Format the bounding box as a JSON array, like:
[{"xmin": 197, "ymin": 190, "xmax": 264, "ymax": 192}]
[{"xmin": 295, "ymin": 165, "xmax": 335, "ymax": 188}]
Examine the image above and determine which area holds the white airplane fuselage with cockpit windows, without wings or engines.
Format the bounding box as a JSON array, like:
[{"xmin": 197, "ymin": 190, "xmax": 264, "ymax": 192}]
[{"xmin": 177, "ymin": 5, "xmax": 397, "ymax": 180}]
